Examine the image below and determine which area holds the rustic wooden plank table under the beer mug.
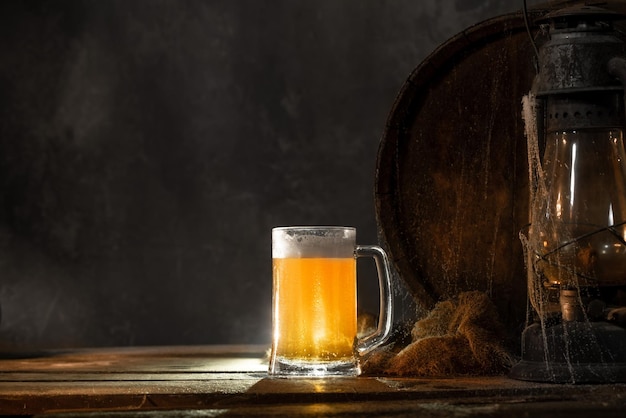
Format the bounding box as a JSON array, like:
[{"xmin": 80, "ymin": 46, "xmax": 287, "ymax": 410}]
[{"xmin": 0, "ymin": 346, "xmax": 626, "ymax": 418}]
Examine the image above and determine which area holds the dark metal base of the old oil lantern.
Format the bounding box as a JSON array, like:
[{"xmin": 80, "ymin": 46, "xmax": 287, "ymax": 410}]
[{"xmin": 509, "ymin": 322, "xmax": 626, "ymax": 383}]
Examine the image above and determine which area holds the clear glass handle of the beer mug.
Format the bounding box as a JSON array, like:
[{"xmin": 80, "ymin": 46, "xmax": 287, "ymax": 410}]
[{"xmin": 354, "ymin": 245, "xmax": 393, "ymax": 355}]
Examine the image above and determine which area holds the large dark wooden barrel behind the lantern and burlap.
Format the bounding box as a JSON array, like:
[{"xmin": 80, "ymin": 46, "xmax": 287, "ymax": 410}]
[{"xmin": 375, "ymin": 1, "xmax": 626, "ymax": 346}]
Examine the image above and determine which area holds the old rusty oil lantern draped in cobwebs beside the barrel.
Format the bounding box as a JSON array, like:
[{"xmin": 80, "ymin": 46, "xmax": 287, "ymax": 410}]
[{"xmin": 511, "ymin": 6, "xmax": 626, "ymax": 383}]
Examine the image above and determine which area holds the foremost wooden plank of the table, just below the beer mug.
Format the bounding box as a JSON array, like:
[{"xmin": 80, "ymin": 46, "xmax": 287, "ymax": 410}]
[{"xmin": 0, "ymin": 378, "xmax": 626, "ymax": 415}]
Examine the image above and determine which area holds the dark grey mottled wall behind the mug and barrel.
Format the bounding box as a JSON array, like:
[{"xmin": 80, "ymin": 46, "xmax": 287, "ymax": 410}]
[{"xmin": 0, "ymin": 0, "xmax": 532, "ymax": 348}]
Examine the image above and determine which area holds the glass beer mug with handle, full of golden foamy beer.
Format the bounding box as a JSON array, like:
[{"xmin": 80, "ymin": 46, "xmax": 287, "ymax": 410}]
[{"xmin": 269, "ymin": 226, "xmax": 392, "ymax": 377}]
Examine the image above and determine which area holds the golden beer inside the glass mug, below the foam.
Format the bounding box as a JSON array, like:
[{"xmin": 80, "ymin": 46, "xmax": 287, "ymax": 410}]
[{"xmin": 273, "ymin": 257, "xmax": 357, "ymax": 362}]
